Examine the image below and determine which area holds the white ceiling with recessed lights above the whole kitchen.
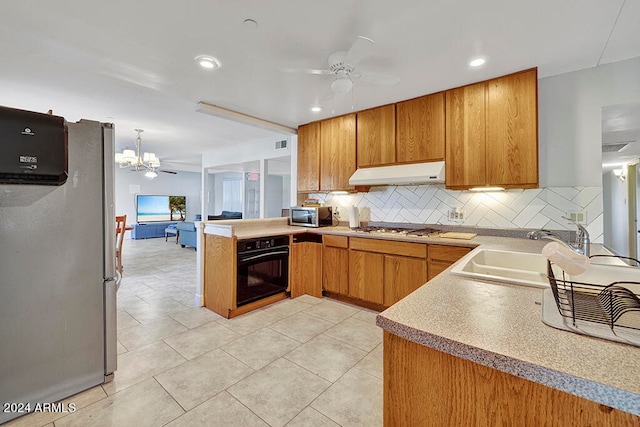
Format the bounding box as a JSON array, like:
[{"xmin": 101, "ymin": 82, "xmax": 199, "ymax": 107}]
[{"xmin": 0, "ymin": 0, "xmax": 640, "ymax": 170}]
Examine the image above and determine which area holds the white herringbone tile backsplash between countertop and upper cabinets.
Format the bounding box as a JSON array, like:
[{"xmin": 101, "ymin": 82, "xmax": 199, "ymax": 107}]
[{"xmin": 309, "ymin": 184, "xmax": 604, "ymax": 243}]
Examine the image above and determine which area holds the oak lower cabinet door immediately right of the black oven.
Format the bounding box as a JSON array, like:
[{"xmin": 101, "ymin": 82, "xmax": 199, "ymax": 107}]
[{"xmin": 289, "ymin": 242, "xmax": 322, "ymax": 298}]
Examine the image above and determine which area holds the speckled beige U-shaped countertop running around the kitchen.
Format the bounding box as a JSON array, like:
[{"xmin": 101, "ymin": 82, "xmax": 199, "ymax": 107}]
[{"xmin": 203, "ymin": 218, "xmax": 640, "ymax": 415}]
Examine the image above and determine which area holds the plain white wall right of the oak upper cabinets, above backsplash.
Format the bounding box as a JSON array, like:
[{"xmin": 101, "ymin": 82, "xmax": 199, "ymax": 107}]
[{"xmin": 538, "ymin": 57, "xmax": 640, "ymax": 187}]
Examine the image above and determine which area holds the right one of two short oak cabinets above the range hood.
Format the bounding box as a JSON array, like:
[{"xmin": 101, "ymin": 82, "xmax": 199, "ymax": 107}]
[{"xmin": 396, "ymin": 92, "xmax": 445, "ymax": 163}]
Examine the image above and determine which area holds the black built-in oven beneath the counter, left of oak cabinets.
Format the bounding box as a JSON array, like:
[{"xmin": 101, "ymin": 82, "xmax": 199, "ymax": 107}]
[{"xmin": 236, "ymin": 236, "xmax": 289, "ymax": 307}]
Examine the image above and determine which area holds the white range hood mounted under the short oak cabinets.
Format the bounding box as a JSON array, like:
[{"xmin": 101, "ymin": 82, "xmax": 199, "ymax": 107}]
[{"xmin": 349, "ymin": 162, "xmax": 444, "ymax": 185}]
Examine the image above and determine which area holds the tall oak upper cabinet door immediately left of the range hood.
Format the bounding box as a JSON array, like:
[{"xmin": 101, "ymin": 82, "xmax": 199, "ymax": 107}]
[{"xmin": 318, "ymin": 113, "xmax": 356, "ymax": 191}]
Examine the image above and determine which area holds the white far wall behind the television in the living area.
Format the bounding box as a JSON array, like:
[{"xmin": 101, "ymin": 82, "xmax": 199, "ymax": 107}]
[{"xmin": 115, "ymin": 166, "xmax": 200, "ymax": 237}]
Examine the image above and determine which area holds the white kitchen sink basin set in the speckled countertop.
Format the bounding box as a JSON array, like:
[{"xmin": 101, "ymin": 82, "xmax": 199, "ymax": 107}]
[{"xmin": 451, "ymin": 249, "xmax": 549, "ymax": 288}]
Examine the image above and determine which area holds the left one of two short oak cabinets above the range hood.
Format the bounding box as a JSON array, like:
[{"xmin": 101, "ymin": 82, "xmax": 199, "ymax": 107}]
[{"xmin": 356, "ymin": 104, "xmax": 396, "ymax": 167}]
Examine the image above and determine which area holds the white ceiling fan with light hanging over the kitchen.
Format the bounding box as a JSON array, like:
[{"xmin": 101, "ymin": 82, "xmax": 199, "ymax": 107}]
[{"xmin": 280, "ymin": 36, "xmax": 400, "ymax": 95}]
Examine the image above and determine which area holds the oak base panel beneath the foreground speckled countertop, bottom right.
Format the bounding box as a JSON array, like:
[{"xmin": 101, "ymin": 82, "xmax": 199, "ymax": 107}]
[{"xmin": 383, "ymin": 331, "xmax": 640, "ymax": 426}]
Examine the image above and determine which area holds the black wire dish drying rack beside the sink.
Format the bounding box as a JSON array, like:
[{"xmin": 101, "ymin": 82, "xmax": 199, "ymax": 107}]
[{"xmin": 547, "ymin": 255, "xmax": 640, "ymax": 335}]
